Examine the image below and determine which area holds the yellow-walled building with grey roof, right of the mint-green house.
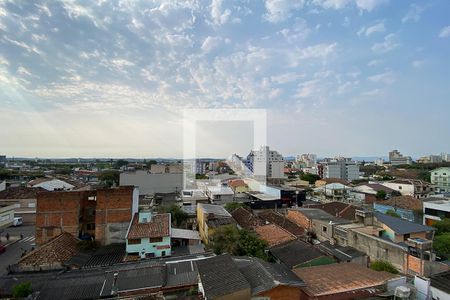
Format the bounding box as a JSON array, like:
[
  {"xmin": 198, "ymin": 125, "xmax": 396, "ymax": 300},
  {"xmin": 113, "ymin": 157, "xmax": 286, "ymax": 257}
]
[{"xmin": 197, "ymin": 203, "xmax": 235, "ymax": 244}]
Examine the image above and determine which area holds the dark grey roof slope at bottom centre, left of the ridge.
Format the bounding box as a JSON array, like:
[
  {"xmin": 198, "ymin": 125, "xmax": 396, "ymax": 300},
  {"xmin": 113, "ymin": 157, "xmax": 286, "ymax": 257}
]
[{"xmin": 196, "ymin": 254, "xmax": 251, "ymax": 298}]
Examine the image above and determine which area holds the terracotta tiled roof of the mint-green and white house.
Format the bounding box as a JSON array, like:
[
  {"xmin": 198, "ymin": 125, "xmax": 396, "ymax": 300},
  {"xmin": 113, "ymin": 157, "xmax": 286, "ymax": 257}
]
[{"xmin": 127, "ymin": 213, "xmax": 170, "ymax": 239}]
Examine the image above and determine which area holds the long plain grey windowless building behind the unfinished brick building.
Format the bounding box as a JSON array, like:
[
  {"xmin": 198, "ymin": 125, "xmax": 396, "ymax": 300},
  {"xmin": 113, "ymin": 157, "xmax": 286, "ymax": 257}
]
[{"xmin": 120, "ymin": 170, "xmax": 183, "ymax": 195}]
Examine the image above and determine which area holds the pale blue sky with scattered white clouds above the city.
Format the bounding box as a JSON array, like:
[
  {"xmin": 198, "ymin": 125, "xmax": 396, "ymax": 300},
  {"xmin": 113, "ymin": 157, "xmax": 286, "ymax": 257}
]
[{"xmin": 0, "ymin": 0, "xmax": 450, "ymax": 158}]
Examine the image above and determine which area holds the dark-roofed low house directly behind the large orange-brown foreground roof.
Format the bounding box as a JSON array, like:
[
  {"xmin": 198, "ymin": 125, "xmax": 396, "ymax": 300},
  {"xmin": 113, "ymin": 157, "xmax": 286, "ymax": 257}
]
[{"xmin": 269, "ymin": 240, "xmax": 334, "ymax": 269}]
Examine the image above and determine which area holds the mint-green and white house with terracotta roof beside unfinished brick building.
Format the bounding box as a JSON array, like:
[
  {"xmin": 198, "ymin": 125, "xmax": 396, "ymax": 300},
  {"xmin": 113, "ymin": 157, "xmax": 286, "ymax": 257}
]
[{"xmin": 126, "ymin": 210, "xmax": 171, "ymax": 258}]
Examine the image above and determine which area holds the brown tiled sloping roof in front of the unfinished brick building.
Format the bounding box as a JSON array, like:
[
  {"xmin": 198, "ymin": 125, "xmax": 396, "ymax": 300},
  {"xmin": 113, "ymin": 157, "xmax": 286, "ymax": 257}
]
[{"xmin": 18, "ymin": 232, "xmax": 79, "ymax": 266}]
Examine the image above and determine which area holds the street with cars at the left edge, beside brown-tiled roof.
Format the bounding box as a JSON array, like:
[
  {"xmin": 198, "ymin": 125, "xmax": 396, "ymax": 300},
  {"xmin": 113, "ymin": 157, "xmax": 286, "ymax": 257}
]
[{"xmin": 0, "ymin": 226, "xmax": 36, "ymax": 276}]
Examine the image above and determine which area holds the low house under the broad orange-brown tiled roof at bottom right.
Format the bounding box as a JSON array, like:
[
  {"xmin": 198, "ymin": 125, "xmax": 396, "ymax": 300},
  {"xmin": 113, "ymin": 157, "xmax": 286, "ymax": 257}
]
[{"xmin": 293, "ymin": 263, "xmax": 401, "ymax": 300}]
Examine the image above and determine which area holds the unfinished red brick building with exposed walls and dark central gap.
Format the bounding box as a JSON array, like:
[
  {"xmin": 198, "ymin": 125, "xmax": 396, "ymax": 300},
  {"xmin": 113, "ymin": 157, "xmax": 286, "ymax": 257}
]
[{"xmin": 36, "ymin": 186, "xmax": 139, "ymax": 245}]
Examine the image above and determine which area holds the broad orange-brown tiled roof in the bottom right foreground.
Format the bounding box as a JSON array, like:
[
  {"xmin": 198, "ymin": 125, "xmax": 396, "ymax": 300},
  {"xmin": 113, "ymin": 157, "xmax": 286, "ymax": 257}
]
[{"xmin": 293, "ymin": 263, "xmax": 398, "ymax": 297}]
